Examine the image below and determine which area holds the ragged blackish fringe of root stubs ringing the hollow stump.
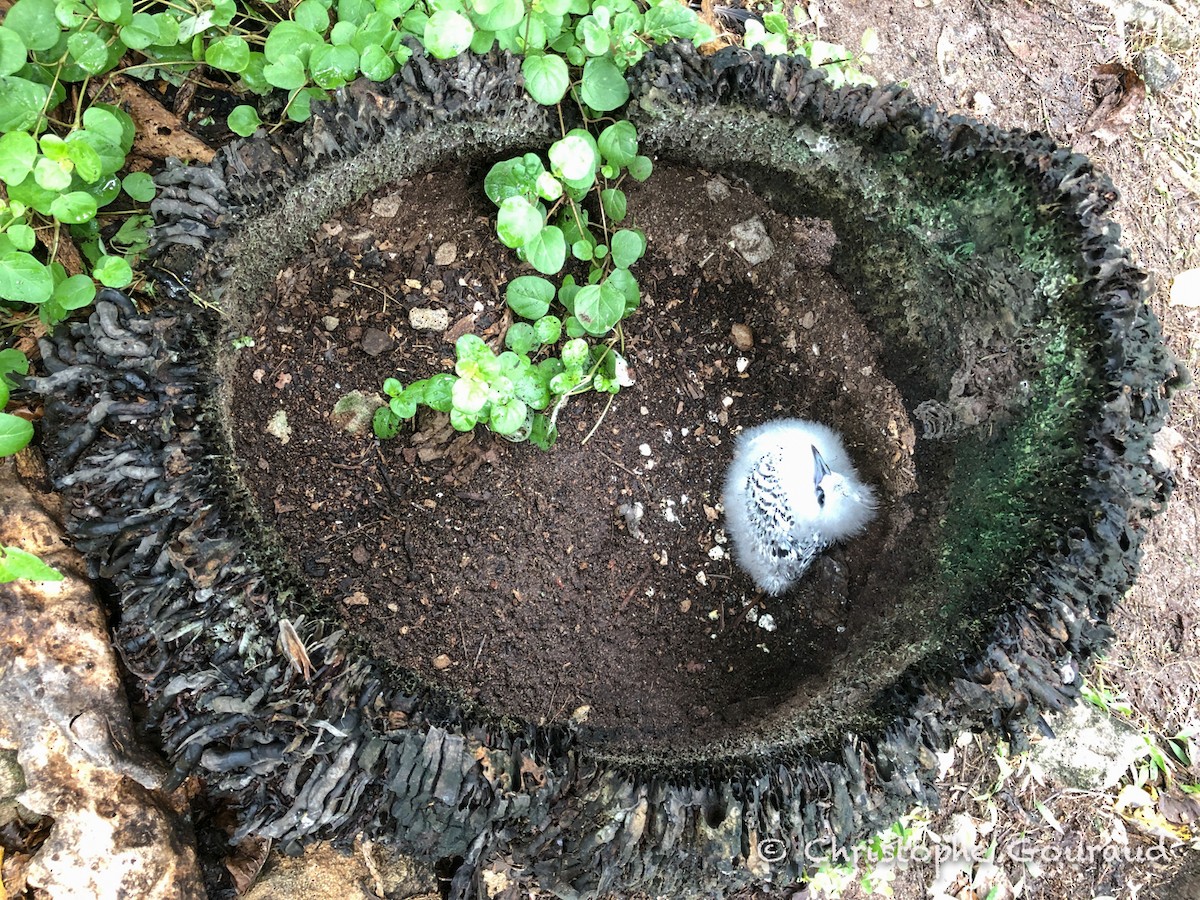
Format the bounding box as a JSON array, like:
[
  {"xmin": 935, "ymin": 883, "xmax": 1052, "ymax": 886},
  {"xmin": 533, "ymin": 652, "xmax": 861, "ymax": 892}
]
[{"xmin": 30, "ymin": 47, "xmax": 1184, "ymax": 898}]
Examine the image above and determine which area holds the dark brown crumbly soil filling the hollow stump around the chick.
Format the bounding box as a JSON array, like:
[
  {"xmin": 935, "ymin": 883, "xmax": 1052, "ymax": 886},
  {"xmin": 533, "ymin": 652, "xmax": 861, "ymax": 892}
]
[{"xmin": 226, "ymin": 168, "xmax": 916, "ymax": 745}]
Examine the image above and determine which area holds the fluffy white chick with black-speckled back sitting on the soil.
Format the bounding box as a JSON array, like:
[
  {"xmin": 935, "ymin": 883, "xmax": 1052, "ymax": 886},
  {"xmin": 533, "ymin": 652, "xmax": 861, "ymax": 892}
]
[{"xmin": 722, "ymin": 419, "xmax": 876, "ymax": 596}]
